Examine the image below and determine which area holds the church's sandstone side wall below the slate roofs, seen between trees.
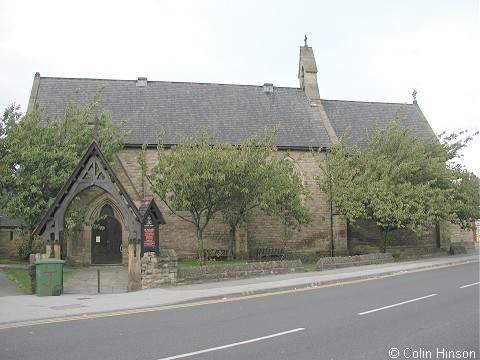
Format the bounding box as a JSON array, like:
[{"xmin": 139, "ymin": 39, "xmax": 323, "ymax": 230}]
[{"xmin": 115, "ymin": 148, "xmax": 466, "ymax": 259}]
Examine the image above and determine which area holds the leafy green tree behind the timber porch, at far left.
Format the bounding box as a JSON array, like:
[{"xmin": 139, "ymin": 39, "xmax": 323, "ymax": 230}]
[{"xmin": 0, "ymin": 91, "xmax": 126, "ymax": 255}]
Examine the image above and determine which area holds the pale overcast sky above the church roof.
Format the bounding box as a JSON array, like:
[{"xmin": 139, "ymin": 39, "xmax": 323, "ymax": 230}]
[{"xmin": 0, "ymin": 0, "xmax": 480, "ymax": 175}]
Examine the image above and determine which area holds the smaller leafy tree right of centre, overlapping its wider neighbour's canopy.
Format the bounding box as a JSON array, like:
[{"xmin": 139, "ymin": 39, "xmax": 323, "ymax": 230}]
[{"xmin": 222, "ymin": 129, "xmax": 312, "ymax": 256}]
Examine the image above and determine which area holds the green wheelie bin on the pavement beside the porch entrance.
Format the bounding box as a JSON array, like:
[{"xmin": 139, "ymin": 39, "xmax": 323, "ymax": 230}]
[{"xmin": 35, "ymin": 259, "xmax": 65, "ymax": 296}]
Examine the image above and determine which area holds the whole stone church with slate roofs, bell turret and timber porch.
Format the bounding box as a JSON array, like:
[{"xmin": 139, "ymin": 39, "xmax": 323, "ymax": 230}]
[{"xmin": 27, "ymin": 41, "xmax": 471, "ymax": 265}]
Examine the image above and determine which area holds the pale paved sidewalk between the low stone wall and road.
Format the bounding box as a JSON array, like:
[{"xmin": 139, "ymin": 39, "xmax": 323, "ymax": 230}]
[{"xmin": 0, "ymin": 247, "xmax": 479, "ymax": 329}]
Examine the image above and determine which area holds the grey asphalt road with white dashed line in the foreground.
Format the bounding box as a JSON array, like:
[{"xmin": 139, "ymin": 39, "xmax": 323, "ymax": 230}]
[{"xmin": 0, "ymin": 263, "xmax": 480, "ymax": 360}]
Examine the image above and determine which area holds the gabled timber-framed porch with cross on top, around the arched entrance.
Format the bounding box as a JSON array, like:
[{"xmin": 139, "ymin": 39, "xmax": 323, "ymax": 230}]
[{"xmin": 33, "ymin": 141, "xmax": 165, "ymax": 291}]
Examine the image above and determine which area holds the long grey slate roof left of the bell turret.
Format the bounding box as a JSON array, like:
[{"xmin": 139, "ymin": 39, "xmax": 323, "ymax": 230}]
[{"xmin": 31, "ymin": 77, "xmax": 331, "ymax": 148}]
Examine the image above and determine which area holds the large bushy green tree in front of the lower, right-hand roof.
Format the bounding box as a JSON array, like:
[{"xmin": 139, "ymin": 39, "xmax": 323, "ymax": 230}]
[{"xmin": 318, "ymin": 122, "xmax": 480, "ymax": 252}]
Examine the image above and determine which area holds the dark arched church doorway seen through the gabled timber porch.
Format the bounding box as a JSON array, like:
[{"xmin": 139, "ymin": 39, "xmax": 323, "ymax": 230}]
[{"xmin": 92, "ymin": 204, "xmax": 122, "ymax": 264}]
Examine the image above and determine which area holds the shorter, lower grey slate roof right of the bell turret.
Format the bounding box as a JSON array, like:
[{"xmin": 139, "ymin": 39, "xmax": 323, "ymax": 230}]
[{"xmin": 322, "ymin": 100, "xmax": 435, "ymax": 146}]
